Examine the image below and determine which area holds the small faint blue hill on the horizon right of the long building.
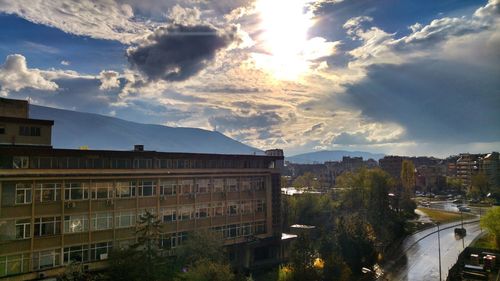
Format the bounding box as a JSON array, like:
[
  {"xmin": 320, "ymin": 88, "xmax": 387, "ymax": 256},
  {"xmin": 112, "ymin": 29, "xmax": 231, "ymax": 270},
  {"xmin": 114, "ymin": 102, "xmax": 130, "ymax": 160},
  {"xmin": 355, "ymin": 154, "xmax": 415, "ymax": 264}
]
[{"xmin": 285, "ymin": 150, "xmax": 384, "ymax": 164}]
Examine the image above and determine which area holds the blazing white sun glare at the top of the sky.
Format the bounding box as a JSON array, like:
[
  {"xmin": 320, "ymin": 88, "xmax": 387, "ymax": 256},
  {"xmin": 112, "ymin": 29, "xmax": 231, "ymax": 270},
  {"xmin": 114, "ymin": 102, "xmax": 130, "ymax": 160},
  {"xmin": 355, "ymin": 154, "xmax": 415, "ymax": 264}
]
[{"xmin": 253, "ymin": 0, "xmax": 314, "ymax": 80}]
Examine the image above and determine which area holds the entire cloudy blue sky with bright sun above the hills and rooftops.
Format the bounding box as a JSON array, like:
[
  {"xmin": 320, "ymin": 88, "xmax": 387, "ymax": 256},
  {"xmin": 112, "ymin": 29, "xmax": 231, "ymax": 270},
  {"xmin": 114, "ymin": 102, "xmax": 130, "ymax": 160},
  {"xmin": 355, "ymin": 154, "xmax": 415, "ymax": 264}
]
[{"xmin": 0, "ymin": 0, "xmax": 500, "ymax": 157}]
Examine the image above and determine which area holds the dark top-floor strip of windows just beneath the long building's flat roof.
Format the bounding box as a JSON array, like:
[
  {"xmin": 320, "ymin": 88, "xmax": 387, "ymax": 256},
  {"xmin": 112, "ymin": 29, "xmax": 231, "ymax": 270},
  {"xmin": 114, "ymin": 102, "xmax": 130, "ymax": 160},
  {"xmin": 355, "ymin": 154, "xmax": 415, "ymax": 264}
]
[{"xmin": 7, "ymin": 155, "xmax": 272, "ymax": 169}]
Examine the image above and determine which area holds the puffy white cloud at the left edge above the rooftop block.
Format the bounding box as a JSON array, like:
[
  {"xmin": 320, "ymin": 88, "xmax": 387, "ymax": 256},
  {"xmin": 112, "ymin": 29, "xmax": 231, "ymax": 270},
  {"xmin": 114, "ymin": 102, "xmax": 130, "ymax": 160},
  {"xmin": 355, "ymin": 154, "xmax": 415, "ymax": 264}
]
[{"xmin": 0, "ymin": 54, "xmax": 58, "ymax": 95}]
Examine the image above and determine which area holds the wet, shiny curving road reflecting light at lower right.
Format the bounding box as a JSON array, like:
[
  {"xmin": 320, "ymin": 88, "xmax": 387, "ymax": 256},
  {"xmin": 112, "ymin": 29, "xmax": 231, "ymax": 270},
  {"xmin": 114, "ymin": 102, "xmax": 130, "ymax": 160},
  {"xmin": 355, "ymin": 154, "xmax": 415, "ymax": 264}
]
[{"xmin": 379, "ymin": 222, "xmax": 481, "ymax": 281}]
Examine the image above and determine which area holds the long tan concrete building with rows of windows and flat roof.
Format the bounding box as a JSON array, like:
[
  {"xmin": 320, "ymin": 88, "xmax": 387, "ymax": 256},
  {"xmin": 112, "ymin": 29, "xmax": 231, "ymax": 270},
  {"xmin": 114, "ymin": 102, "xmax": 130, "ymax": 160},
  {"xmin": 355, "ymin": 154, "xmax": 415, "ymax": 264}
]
[{"xmin": 0, "ymin": 97, "xmax": 283, "ymax": 280}]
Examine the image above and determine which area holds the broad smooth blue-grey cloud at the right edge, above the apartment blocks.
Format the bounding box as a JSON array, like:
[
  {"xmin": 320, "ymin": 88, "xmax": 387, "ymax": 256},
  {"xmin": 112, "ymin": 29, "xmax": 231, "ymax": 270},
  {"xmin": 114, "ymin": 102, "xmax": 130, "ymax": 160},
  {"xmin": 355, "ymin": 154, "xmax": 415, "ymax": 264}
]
[{"xmin": 339, "ymin": 58, "xmax": 500, "ymax": 143}]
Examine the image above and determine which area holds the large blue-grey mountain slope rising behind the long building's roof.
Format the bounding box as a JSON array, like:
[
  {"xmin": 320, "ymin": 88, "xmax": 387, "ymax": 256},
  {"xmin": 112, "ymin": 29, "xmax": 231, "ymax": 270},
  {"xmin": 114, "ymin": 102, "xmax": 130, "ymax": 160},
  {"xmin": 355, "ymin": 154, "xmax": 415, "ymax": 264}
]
[{"xmin": 30, "ymin": 105, "xmax": 263, "ymax": 154}]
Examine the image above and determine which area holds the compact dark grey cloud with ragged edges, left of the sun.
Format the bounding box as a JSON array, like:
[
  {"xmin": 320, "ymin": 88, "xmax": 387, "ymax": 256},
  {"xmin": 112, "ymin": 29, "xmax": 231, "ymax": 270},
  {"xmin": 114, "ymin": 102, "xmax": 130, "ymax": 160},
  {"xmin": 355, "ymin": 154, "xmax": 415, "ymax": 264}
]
[{"xmin": 127, "ymin": 25, "xmax": 236, "ymax": 81}]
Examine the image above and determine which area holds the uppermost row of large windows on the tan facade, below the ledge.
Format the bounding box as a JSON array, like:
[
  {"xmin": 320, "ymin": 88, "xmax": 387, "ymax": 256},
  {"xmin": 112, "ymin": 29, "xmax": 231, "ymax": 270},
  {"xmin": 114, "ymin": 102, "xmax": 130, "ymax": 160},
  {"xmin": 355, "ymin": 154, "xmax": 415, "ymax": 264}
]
[{"xmin": 15, "ymin": 177, "xmax": 265, "ymax": 204}]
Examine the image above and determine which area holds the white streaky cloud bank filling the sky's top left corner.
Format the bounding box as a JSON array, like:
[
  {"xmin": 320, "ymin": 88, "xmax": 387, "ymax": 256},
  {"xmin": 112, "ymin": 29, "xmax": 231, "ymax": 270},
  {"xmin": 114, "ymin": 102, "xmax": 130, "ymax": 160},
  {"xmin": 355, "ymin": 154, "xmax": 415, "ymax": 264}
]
[{"xmin": 0, "ymin": 0, "xmax": 149, "ymax": 43}]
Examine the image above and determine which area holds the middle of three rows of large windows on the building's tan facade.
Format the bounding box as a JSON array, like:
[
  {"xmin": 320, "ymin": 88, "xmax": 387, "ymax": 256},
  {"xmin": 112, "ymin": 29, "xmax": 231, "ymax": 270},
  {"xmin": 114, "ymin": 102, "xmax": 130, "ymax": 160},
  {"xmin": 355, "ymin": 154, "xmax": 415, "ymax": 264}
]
[{"xmin": 15, "ymin": 200, "xmax": 266, "ymax": 239}]
